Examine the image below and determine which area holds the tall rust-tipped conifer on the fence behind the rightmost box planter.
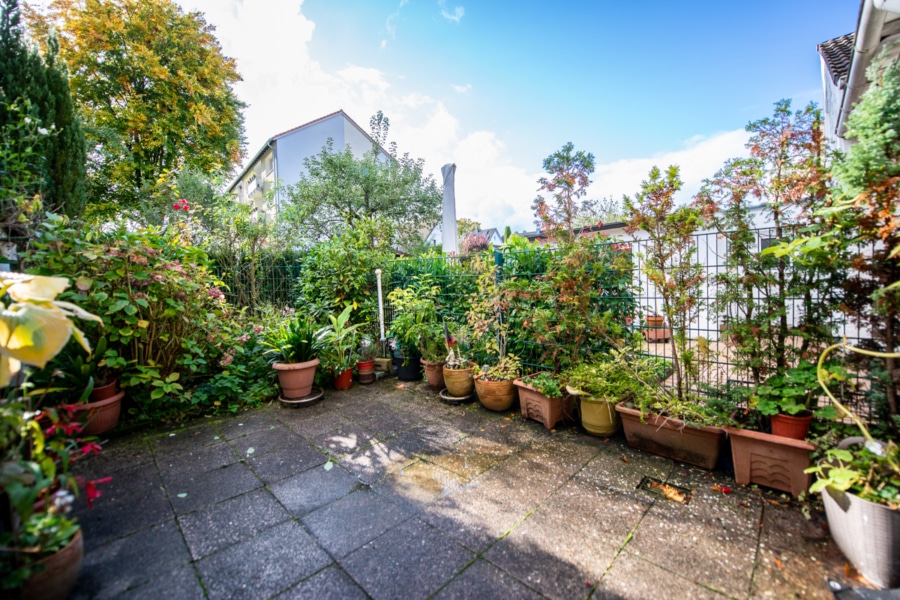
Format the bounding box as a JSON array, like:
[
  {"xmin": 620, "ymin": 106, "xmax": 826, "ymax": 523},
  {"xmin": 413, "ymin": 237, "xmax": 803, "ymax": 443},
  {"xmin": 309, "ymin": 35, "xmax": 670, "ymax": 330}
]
[{"xmin": 698, "ymin": 100, "xmax": 844, "ymax": 385}]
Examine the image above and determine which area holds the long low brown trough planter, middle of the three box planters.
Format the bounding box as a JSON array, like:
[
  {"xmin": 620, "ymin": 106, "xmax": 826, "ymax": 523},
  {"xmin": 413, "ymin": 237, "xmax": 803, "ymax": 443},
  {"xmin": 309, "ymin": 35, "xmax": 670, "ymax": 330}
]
[{"xmin": 616, "ymin": 404, "xmax": 725, "ymax": 469}]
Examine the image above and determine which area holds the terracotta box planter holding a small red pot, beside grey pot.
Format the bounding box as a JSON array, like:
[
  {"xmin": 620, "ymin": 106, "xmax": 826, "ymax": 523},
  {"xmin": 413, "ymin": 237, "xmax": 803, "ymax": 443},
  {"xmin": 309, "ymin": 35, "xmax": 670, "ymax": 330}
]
[{"xmin": 725, "ymin": 427, "xmax": 815, "ymax": 498}]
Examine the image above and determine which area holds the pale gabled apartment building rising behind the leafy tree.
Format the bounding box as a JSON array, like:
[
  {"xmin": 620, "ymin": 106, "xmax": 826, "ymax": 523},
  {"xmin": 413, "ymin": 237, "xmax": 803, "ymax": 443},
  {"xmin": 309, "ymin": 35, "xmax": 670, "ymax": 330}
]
[{"xmin": 228, "ymin": 110, "xmax": 391, "ymax": 212}]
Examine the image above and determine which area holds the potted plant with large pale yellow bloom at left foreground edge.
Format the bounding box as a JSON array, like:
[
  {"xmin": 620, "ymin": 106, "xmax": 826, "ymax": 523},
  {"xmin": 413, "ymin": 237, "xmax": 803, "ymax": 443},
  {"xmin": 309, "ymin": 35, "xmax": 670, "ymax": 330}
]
[{"xmin": 0, "ymin": 273, "xmax": 100, "ymax": 598}]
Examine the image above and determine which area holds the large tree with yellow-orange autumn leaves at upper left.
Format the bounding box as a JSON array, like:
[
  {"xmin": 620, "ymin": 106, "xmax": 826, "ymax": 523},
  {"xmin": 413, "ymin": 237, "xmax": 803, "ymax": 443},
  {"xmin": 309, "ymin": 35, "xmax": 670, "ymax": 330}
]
[{"xmin": 32, "ymin": 0, "xmax": 244, "ymax": 216}]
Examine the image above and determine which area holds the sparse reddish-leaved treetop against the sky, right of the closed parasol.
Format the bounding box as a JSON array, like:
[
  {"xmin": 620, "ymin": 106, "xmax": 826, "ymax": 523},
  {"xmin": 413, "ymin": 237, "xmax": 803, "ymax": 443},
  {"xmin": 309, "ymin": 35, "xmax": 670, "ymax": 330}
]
[{"xmin": 531, "ymin": 142, "xmax": 594, "ymax": 242}]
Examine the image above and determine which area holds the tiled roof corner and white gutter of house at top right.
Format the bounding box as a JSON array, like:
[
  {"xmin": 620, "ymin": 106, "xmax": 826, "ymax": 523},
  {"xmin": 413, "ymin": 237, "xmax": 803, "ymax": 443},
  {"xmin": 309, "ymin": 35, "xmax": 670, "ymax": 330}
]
[{"xmin": 817, "ymin": 0, "xmax": 900, "ymax": 150}]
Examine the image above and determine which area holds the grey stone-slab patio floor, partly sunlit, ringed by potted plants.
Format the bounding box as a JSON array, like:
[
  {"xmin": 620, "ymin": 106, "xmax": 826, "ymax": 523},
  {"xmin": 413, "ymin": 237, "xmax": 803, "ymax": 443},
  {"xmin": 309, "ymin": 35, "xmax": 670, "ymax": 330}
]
[{"xmin": 72, "ymin": 379, "xmax": 859, "ymax": 600}]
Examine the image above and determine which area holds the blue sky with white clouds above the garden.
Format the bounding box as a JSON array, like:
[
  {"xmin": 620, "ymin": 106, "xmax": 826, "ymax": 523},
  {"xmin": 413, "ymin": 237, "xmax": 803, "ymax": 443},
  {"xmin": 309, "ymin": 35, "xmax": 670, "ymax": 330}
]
[{"xmin": 180, "ymin": 0, "xmax": 859, "ymax": 231}]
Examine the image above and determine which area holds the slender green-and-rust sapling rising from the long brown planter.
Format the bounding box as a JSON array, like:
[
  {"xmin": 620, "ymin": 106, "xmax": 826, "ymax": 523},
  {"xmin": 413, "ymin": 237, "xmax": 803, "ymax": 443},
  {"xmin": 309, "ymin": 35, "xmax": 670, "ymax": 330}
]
[{"xmin": 625, "ymin": 165, "xmax": 705, "ymax": 401}]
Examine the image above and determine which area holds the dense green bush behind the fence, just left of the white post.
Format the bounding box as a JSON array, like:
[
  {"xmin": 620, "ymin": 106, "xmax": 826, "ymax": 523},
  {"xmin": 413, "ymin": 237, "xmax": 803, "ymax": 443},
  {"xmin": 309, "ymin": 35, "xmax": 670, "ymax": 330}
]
[{"xmin": 297, "ymin": 219, "xmax": 393, "ymax": 334}]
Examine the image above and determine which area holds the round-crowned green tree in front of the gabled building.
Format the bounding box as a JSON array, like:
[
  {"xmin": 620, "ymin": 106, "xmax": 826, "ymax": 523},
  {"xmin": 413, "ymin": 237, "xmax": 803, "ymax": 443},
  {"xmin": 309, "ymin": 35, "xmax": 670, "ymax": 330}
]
[{"xmin": 281, "ymin": 112, "xmax": 442, "ymax": 248}]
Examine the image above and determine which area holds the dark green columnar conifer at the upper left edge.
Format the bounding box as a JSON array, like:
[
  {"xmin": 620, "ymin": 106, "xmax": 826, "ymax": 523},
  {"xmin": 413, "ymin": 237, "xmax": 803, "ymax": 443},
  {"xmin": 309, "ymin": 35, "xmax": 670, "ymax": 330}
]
[{"xmin": 0, "ymin": 0, "xmax": 85, "ymax": 217}]
